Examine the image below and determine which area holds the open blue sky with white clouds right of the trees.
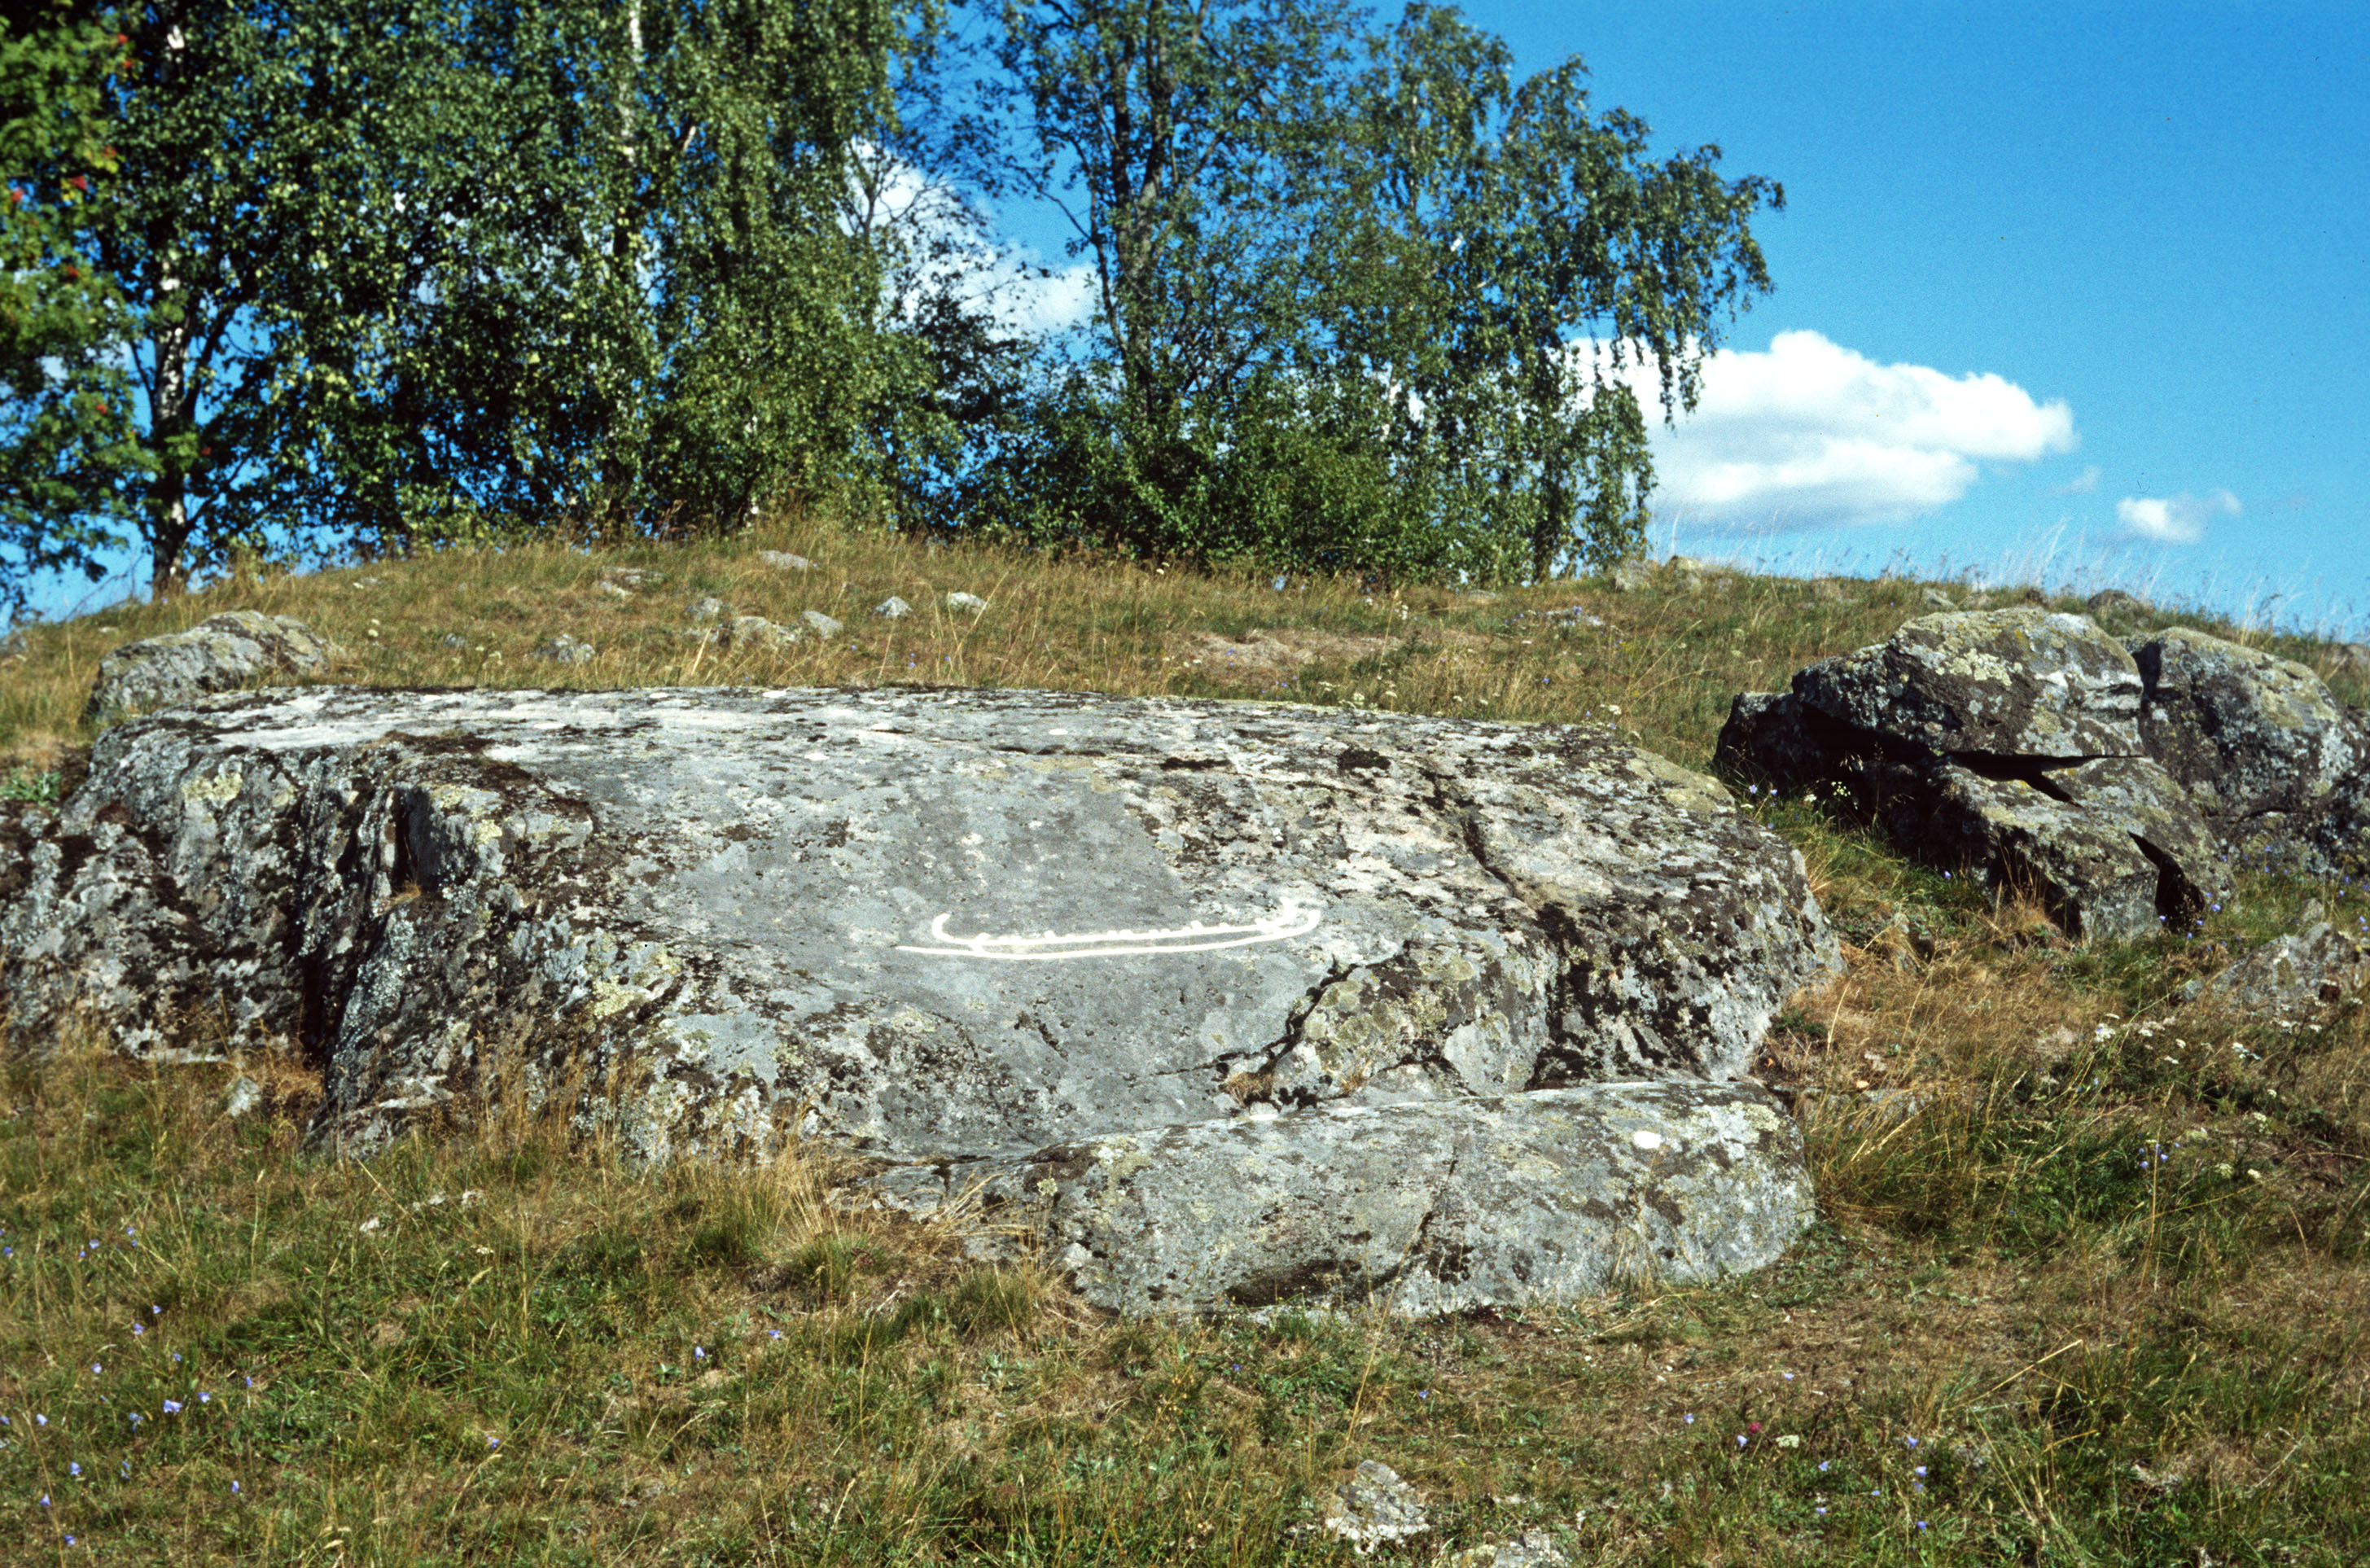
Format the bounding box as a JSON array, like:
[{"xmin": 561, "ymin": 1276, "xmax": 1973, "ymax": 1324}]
[{"xmin": 1467, "ymin": 0, "xmax": 2370, "ymax": 637}]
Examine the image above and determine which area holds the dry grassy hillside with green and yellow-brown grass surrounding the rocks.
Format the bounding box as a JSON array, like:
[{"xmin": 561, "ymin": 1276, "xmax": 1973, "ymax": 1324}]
[{"xmin": 0, "ymin": 526, "xmax": 2370, "ymax": 1568}]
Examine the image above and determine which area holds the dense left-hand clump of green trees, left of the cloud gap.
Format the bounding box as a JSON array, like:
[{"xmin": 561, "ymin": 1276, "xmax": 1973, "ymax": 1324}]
[{"xmin": 0, "ymin": 0, "xmax": 927, "ymax": 592}]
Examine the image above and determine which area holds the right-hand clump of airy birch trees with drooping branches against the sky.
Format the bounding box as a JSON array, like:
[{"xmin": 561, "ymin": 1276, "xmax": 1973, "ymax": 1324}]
[{"xmin": 962, "ymin": 0, "xmax": 1782, "ymax": 578}]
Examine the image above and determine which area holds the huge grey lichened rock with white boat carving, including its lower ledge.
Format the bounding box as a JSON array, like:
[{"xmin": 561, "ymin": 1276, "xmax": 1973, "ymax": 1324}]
[{"xmin": 0, "ymin": 687, "xmax": 1834, "ymax": 1310}]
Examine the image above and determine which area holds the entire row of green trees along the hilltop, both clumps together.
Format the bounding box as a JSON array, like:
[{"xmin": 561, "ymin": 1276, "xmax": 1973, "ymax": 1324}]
[{"xmin": 0, "ymin": 0, "xmax": 1782, "ymax": 602}]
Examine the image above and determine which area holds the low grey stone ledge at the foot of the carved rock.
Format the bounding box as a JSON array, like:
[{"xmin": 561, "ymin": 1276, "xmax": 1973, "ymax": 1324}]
[{"xmin": 877, "ymin": 1083, "xmax": 1816, "ymax": 1315}]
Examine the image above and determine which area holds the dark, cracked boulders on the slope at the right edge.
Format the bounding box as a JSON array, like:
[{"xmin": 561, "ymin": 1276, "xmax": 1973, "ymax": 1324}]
[{"xmin": 1718, "ymin": 607, "xmax": 2370, "ymax": 938}]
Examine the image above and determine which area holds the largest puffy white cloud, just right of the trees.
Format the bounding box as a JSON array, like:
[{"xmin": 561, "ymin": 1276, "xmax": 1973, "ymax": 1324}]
[{"xmin": 1592, "ymin": 331, "xmax": 2076, "ymax": 531}]
